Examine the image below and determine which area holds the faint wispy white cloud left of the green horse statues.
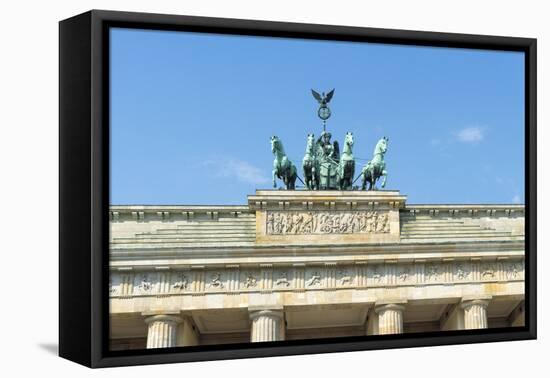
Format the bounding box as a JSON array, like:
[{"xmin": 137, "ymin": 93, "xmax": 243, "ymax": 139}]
[{"xmin": 204, "ymin": 158, "xmax": 270, "ymax": 185}]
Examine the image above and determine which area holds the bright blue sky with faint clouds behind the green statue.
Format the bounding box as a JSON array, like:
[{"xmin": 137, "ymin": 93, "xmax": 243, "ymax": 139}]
[{"xmin": 111, "ymin": 29, "xmax": 524, "ymax": 204}]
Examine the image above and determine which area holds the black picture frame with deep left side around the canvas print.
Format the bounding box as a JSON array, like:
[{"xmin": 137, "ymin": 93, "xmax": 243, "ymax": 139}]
[{"xmin": 59, "ymin": 10, "xmax": 537, "ymax": 368}]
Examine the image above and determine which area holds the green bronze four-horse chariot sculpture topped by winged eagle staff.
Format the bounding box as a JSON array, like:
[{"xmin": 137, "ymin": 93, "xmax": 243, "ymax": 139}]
[{"xmin": 271, "ymin": 89, "xmax": 388, "ymax": 190}]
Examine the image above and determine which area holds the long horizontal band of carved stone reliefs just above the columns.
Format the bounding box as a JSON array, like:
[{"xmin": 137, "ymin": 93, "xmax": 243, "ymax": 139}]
[{"xmin": 109, "ymin": 260, "xmax": 525, "ymax": 297}]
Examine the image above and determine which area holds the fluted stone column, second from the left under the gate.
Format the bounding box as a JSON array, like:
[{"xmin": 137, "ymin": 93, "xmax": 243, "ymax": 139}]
[{"xmin": 250, "ymin": 309, "xmax": 285, "ymax": 343}]
